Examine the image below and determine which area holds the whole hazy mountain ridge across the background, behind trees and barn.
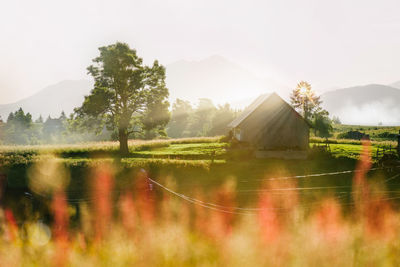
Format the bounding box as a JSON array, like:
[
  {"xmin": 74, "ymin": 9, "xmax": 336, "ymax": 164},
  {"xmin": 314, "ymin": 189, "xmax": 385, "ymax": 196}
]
[{"xmin": 0, "ymin": 56, "xmax": 400, "ymax": 125}]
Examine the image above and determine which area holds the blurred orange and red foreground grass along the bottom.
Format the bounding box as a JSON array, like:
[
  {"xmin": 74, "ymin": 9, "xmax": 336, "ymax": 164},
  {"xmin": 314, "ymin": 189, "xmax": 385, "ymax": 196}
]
[{"xmin": 0, "ymin": 150, "xmax": 400, "ymax": 266}]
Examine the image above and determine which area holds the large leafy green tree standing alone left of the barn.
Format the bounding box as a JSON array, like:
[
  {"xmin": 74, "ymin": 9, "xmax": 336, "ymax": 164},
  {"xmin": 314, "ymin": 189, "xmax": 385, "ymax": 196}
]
[{"xmin": 75, "ymin": 42, "xmax": 168, "ymax": 154}]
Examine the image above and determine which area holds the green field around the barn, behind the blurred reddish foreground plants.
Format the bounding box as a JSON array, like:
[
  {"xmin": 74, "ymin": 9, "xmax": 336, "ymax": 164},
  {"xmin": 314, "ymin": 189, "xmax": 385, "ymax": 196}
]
[{"xmin": 0, "ymin": 137, "xmax": 396, "ymax": 211}]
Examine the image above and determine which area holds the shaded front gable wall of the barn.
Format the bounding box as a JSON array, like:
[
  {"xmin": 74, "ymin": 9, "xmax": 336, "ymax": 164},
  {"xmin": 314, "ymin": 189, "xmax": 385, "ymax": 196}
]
[{"xmin": 241, "ymin": 96, "xmax": 309, "ymax": 150}]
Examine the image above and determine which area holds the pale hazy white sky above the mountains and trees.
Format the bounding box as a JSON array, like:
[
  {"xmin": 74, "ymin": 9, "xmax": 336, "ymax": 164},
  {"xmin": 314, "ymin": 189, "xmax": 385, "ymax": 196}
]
[{"xmin": 0, "ymin": 0, "xmax": 400, "ymax": 103}]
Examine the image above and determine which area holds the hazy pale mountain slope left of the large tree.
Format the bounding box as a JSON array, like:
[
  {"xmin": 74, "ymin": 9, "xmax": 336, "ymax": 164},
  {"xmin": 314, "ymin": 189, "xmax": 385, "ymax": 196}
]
[{"xmin": 0, "ymin": 80, "xmax": 92, "ymax": 120}]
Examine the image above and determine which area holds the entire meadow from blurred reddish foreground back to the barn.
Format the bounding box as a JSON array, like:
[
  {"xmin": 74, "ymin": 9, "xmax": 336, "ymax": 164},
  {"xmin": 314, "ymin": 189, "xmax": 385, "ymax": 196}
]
[{"xmin": 0, "ymin": 137, "xmax": 400, "ymax": 266}]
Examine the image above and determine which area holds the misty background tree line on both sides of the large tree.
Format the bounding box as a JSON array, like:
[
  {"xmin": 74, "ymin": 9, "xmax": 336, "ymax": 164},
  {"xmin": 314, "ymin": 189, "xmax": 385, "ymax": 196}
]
[{"xmin": 0, "ymin": 98, "xmax": 239, "ymax": 145}]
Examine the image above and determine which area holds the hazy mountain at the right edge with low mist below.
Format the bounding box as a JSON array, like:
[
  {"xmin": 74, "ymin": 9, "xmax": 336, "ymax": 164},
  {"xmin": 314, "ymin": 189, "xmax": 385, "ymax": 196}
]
[{"xmin": 321, "ymin": 84, "xmax": 400, "ymax": 125}]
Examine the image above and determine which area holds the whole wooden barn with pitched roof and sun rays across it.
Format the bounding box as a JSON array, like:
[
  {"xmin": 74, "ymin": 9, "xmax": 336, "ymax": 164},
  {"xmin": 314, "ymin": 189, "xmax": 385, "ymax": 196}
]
[{"xmin": 228, "ymin": 93, "xmax": 310, "ymax": 159}]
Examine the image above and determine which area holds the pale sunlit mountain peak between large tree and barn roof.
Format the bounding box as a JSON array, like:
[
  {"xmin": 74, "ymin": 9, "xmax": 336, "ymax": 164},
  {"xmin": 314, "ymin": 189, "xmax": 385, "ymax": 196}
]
[{"xmin": 166, "ymin": 55, "xmax": 278, "ymax": 107}]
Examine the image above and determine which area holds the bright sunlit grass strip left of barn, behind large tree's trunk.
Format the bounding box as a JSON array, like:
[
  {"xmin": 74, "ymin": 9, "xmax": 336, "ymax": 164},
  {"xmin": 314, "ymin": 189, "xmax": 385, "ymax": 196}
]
[{"xmin": 0, "ymin": 137, "xmax": 223, "ymax": 167}]
